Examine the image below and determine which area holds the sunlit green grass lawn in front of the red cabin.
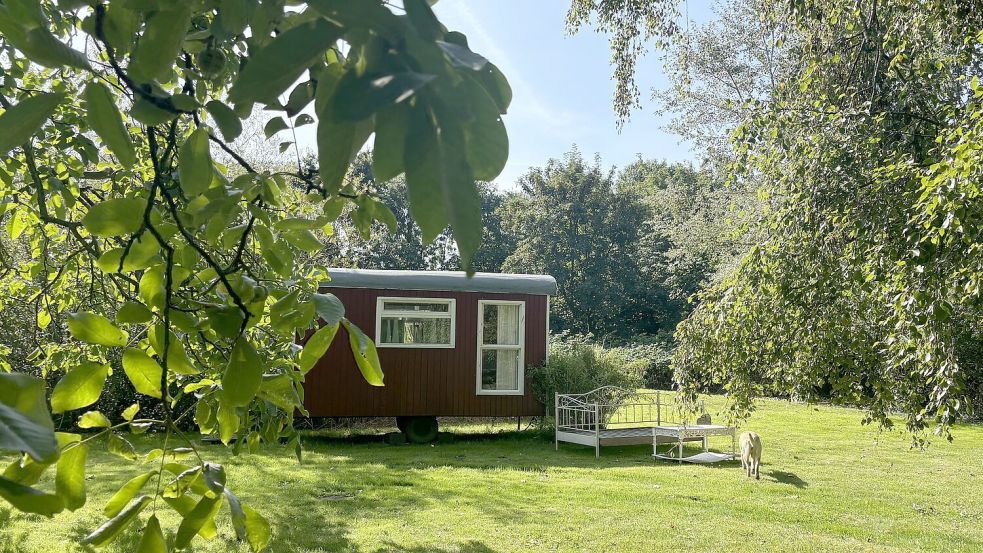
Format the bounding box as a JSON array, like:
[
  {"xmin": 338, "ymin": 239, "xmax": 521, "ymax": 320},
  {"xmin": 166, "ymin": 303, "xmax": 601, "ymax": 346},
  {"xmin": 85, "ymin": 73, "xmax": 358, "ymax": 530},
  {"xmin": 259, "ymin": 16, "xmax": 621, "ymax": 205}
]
[{"xmin": 0, "ymin": 401, "xmax": 983, "ymax": 553}]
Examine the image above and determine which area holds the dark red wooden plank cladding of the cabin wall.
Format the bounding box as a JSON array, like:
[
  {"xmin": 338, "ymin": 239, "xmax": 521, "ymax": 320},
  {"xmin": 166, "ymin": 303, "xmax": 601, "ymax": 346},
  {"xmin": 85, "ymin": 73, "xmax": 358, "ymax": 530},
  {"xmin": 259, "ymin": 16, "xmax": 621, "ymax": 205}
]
[{"xmin": 304, "ymin": 288, "xmax": 547, "ymax": 417}]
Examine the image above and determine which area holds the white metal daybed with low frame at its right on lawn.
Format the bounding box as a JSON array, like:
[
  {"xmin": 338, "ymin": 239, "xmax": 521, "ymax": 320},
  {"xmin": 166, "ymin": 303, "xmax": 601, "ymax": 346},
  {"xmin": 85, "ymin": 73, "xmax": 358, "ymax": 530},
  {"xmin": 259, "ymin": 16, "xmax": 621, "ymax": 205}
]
[{"xmin": 554, "ymin": 386, "xmax": 735, "ymax": 462}]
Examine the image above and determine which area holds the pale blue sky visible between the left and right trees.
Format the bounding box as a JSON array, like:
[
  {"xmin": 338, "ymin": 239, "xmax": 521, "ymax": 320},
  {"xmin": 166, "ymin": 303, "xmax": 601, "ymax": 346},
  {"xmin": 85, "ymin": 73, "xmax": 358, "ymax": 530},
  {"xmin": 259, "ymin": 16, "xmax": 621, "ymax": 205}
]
[{"xmin": 434, "ymin": 0, "xmax": 712, "ymax": 189}]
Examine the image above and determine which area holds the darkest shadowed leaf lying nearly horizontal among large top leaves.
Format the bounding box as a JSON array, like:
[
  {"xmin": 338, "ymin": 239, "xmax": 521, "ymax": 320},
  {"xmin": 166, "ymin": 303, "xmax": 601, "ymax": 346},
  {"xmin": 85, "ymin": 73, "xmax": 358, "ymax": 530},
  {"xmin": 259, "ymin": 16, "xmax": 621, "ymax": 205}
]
[{"xmin": 330, "ymin": 69, "xmax": 434, "ymax": 121}]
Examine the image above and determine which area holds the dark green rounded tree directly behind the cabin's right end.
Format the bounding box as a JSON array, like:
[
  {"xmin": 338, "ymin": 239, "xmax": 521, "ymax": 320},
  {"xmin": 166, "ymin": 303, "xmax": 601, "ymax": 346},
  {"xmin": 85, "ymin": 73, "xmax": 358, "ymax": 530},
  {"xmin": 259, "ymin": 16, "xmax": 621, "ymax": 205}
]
[{"xmin": 504, "ymin": 149, "xmax": 645, "ymax": 334}]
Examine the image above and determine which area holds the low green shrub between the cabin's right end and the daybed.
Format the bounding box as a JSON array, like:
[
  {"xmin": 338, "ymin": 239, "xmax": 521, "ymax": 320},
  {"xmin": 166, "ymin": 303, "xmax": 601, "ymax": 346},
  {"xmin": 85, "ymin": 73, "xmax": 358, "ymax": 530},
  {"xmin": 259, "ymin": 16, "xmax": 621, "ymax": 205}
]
[{"xmin": 530, "ymin": 333, "xmax": 646, "ymax": 407}]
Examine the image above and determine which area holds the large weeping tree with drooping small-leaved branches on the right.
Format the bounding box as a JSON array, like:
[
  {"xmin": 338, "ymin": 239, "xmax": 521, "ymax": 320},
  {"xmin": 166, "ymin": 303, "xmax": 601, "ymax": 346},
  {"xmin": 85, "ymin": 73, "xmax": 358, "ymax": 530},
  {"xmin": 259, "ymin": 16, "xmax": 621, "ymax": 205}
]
[{"xmin": 572, "ymin": 0, "xmax": 983, "ymax": 435}]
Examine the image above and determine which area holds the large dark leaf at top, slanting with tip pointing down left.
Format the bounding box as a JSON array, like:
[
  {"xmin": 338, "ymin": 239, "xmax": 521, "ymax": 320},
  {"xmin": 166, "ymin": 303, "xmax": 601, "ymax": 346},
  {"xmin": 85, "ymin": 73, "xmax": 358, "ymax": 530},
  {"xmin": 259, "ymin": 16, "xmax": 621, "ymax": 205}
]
[{"xmin": 229, "ymin": 18, "xmax": 342, "ymax": 104}]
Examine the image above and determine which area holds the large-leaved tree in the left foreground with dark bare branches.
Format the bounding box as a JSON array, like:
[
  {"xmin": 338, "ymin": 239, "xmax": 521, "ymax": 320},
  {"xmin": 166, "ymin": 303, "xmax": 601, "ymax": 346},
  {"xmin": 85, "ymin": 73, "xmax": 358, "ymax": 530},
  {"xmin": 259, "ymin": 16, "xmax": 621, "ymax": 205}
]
[{"xmin": 0, "ymin": 0, "xmax": 511, "ymax": 551}]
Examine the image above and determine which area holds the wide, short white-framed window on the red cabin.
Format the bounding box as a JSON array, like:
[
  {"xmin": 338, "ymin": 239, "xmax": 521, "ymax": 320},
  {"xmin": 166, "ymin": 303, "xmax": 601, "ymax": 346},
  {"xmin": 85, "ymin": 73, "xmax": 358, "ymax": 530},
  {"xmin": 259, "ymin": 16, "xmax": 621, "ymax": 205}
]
[{"xmin": 376, "ymin": 298, "xmax": 454, "ymax": 348}]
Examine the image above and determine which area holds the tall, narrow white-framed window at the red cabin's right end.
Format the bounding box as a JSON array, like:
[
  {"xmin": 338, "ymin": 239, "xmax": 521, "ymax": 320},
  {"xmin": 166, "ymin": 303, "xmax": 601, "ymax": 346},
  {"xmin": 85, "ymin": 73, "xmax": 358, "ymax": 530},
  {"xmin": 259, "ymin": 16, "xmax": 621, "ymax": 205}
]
[{"xmin": 478, "ymin": 301, "xmax": 526, "ymax": 394}]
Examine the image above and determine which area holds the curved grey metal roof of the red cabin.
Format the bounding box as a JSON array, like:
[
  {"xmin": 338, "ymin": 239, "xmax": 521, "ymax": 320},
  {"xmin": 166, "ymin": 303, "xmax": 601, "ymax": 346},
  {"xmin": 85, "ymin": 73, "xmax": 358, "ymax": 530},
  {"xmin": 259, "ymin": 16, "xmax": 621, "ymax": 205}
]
[{"xmin": 322, "ymin": 268, "xmax": 556, "ymax": 296}]
